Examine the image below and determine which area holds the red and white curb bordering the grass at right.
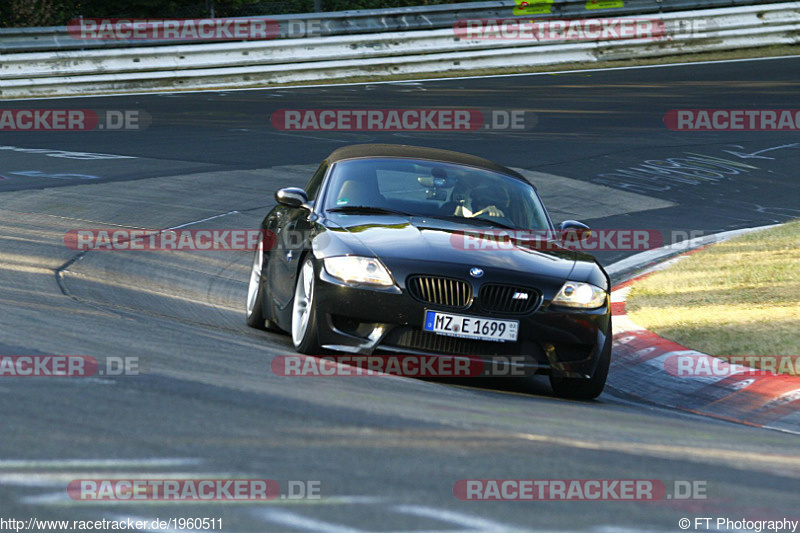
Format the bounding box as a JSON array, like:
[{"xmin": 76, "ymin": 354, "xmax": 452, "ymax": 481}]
[{"xmin": 609, "ymin": 254, "xmax": 800, "ymax": 433}]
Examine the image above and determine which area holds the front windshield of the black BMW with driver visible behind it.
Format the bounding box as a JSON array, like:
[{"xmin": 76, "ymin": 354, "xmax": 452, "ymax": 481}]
[{"xmin": 325, "ymin": 158, "xmax": 550, "ymax": 230}]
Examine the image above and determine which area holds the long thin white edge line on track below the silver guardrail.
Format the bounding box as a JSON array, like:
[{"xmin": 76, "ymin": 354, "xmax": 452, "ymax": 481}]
[{"xmin": 5, "ymin": 55, "xmax": 800, "ymax": 102}]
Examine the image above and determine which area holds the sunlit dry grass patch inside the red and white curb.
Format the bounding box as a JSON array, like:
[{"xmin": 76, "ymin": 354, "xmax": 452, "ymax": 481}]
[{"xmin": 626, "ymin": 220, "xmax": 800, "ymax": 372}]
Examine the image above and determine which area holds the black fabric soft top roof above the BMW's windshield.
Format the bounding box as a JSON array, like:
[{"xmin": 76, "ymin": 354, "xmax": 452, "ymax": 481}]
[{"xmin": 328, "ymin": 144, "xmax": 527, "ymax": 182}]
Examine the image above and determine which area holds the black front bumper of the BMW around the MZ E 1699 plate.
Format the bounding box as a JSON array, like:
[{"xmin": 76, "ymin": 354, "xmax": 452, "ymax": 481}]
[{"xmin": 315, "ymin": 268, "xmax": 611, "ymax": 378}]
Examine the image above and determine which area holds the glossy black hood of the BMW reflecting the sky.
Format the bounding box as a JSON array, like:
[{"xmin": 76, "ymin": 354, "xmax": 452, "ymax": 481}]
[{"xmin": 326, "ymin": 214, "xmax": 594, "ymax": 281}]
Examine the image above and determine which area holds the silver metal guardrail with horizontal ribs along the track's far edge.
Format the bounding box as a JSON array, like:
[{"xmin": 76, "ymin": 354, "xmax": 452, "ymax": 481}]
[{"xmin": 0, "ymin": 2, "xmax": 800, "ymax": 98}]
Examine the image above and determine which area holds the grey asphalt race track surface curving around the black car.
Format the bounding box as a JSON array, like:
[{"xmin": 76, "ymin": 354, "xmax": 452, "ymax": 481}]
[{"xmin": 0, "ymin": 58, "xmax": 800, "ymax": 533}]
